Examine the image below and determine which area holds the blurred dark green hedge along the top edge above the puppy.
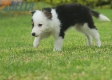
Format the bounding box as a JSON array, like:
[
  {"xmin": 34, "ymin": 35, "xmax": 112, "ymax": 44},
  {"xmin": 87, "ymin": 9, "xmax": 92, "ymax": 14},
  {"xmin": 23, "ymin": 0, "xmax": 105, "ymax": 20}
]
[{"xmin": 24, "ymin": 0, "xmax": 112, "ymax": 8}]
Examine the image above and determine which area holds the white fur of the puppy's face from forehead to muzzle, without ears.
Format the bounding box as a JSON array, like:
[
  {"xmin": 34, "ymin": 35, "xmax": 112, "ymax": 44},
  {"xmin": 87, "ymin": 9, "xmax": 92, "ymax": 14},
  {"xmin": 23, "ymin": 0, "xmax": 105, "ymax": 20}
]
[{"xmin": 32, "ymin": 11, "xmax": 48, "ymax": 37}]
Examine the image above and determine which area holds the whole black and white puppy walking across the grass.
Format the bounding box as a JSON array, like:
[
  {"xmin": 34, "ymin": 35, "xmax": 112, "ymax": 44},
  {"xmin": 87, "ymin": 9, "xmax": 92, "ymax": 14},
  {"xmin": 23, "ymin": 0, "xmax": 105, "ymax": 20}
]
[{"xmin": 31, "ymin": 4, "xmax": 110, "ymax": 51}]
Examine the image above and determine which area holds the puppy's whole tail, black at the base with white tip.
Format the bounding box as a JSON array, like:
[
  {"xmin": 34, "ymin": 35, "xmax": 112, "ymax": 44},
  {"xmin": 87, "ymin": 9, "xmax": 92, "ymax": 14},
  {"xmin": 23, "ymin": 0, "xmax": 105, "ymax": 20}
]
[{"xmin": 90, "ymin": 10, "xmax": 110, "ymax": 22}]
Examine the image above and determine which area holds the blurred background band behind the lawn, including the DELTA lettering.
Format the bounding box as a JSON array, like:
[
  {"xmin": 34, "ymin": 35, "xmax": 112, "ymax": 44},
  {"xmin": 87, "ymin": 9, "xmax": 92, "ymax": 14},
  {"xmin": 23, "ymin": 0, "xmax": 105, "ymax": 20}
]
[{"xmin": 0, "ymin": 0, "xmax": 112, "ymax": 19}]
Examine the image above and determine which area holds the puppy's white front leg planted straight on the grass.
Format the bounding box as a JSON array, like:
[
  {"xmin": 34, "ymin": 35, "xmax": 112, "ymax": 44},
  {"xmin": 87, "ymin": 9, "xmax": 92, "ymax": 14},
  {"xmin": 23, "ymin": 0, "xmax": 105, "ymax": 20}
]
[{"xmin": 53, "ymin": 36, "xmax": 64, "ymax": 51}]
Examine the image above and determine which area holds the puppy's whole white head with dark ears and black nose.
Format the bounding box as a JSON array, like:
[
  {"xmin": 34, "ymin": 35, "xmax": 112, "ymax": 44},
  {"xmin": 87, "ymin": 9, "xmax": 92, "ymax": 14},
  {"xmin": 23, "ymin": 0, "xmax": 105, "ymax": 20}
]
[{"xmin": 31, "ymin": 8, "xmax": 52, "ymax": 37}]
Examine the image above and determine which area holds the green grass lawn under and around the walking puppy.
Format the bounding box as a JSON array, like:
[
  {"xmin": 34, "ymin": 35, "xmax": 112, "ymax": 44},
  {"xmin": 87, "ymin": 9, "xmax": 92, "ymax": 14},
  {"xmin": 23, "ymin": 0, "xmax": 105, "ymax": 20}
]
[{"xmin": 0, "ymin": 9, "xmax": 112, "ymax": 80}]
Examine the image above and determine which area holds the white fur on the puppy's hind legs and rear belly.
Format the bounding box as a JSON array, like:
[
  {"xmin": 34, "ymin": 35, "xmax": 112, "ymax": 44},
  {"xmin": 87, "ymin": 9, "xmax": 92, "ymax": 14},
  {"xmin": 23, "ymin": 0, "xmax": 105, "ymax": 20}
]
[{"xmin": 75, "ymin": 23, "xmax": 101, "ymax": 47}]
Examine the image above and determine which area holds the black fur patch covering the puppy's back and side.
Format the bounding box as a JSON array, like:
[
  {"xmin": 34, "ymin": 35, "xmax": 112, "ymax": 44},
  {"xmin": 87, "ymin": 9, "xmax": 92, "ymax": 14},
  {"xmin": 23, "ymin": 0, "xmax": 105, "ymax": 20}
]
[{"xmin": 55, "ymin": 4, "xmax": 99, "ymax": 38}]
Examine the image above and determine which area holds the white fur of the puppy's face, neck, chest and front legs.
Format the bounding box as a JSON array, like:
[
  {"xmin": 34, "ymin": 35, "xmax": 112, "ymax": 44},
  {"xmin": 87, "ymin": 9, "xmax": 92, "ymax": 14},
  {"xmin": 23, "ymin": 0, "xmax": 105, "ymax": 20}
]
[{"xmin": 32, "ymin": 9, "xmax": 63, "ymax": 51}]
